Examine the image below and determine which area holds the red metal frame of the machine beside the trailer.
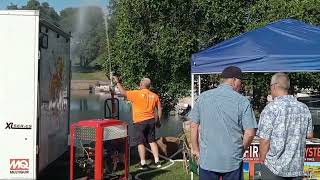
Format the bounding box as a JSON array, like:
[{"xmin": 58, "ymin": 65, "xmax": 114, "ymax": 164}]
[{"xmin": 70, "ymin": 119, "xmax": 129, "ymax": 180}]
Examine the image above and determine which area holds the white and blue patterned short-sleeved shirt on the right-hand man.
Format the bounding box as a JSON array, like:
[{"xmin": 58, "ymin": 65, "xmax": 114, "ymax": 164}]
[{"xmin": 257, "ymin": 95, "xmax": 312, "ymax": 177}]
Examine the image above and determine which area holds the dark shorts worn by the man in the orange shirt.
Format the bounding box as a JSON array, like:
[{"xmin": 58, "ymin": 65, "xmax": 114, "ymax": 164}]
[{"xmin": 133, "ymin": 119, "xmax": 155, "ymax": 145}]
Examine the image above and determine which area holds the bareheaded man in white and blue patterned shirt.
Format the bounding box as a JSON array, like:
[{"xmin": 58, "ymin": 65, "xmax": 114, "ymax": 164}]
[{"xmin": 257, "ymin": 73, "xmax": 313, "ymax": 180}]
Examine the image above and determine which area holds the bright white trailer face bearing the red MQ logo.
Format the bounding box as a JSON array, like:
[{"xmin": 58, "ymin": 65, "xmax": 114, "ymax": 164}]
[{"xmin": 0, "ymin": 11, "xmax": 39, "ymax": 179}]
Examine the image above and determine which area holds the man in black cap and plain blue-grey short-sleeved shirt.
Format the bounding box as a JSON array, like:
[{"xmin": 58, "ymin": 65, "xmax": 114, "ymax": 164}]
[{"xmin": 189, "ymin": 66, "xmax": 257, "ymax": 180}]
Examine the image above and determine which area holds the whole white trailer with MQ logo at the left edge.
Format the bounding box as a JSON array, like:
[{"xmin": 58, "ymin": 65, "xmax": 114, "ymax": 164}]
[{"xmin": 0, "ymin": 10, "xmax": 71, "ymax": 179}]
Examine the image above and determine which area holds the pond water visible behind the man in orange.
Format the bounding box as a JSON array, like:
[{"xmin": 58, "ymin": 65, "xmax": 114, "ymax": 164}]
[{"xmin": 70, "ymin": 90, "xmax": 182, "ymax": 145}]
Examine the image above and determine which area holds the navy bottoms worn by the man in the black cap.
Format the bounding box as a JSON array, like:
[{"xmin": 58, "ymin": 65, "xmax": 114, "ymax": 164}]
[{"xmin": 199, "ymin": 163, "xmax": 243, "ymax": 180}]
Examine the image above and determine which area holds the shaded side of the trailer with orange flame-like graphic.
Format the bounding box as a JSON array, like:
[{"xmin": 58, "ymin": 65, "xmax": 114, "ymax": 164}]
[{"xmin": 39, "ymin": 21, "xmax": 70, "ymax": 171}]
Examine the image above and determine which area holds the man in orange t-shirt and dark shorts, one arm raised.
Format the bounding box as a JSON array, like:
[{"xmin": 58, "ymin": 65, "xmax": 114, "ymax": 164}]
[{"xmin": 113, "ymin": 76, "xmax": 162, "ymax": 169}]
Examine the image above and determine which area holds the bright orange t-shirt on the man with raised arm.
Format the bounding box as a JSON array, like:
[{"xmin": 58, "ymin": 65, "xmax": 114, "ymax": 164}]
[{"xmin": 127, "ymin": 89, "xmax": 160, "ymax": 123}]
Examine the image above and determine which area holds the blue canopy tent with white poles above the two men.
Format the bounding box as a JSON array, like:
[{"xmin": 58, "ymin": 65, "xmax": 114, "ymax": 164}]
[{"xmin": 191, "ymin": 19, "xmax": 320, "ymax": 106}]
